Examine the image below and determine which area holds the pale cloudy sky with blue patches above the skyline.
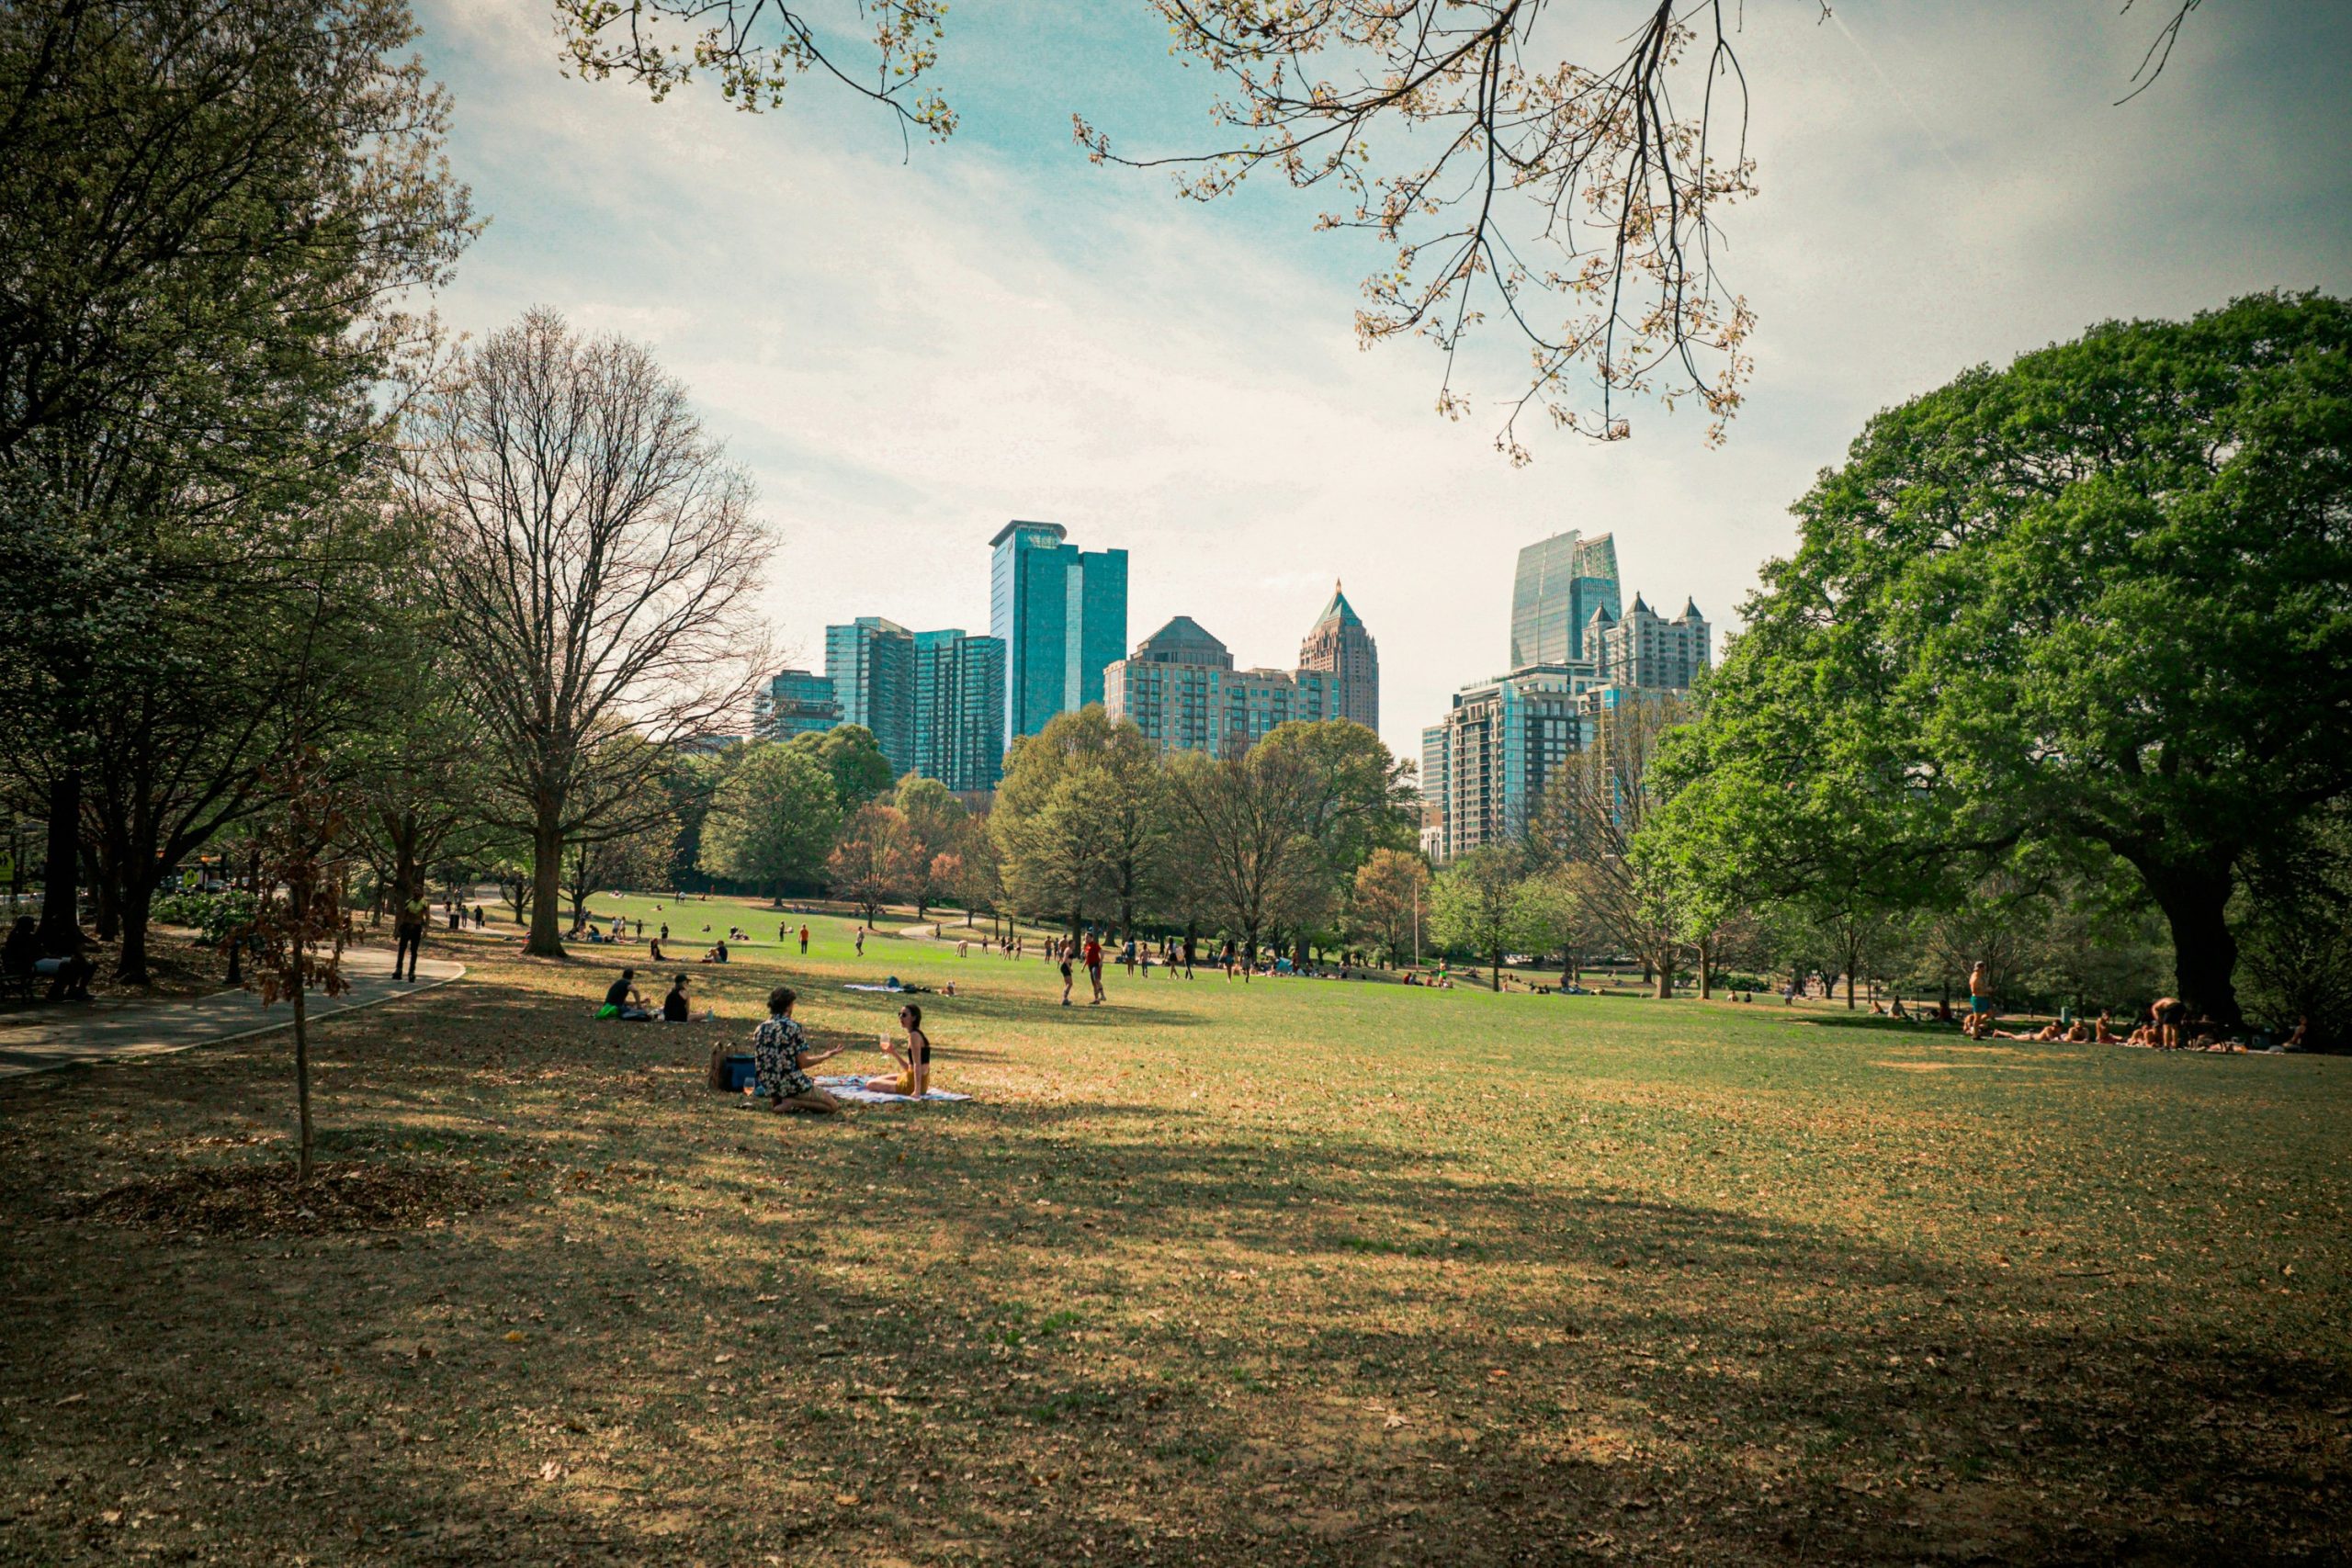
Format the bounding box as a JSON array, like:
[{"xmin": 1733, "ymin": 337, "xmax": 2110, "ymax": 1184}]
[{"xmin": 416, "ymin": 0, "xmax": 2352, "ymax": 757}]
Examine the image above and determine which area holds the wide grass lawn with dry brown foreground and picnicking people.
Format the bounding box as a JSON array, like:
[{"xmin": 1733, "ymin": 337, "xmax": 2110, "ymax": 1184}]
[{"xmin": 0, "ymin": 900, "xmax": 2352, "ymax": 1565}]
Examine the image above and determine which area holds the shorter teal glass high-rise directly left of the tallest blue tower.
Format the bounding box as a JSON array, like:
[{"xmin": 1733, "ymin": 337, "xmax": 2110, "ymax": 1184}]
[{"xmin": 826, "ymin": 616, "xmax": 1004, "ymax": 790}]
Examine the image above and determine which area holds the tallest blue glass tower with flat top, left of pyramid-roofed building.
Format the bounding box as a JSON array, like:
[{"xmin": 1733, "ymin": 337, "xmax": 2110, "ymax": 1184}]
[{"xmin": 988, "ymin": 522, "xmax": 1126, "ymax": 745}]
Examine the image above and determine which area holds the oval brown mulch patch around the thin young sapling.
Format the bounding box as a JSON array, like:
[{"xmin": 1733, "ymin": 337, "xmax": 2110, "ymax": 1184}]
[{"xmin": 68, "ymin": 1161, "xmax": 489, "ymax": 1236}]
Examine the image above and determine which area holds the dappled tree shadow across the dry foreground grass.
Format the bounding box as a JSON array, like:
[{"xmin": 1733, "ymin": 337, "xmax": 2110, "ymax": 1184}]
[{"xmin": 0, "ymin": 985, "xmax": 2352, "ymax": 1568}]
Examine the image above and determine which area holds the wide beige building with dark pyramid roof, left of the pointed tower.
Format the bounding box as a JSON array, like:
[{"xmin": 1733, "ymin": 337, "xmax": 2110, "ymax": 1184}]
[{"xmin": 1103, "ymin": 616, "xmax": 1345, "ymax": 757}]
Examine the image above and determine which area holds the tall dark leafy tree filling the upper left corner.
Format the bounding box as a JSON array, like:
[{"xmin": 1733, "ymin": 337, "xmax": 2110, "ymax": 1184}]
[{"xmin": 0, "ymin": 0, "xmax": 473, "ymax": 980}]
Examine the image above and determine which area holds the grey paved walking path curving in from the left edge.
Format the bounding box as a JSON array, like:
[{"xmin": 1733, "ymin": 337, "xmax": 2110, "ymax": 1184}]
[{"xmin": 0, "ymin": 947, "xmax": 466, "ymax": 1077}]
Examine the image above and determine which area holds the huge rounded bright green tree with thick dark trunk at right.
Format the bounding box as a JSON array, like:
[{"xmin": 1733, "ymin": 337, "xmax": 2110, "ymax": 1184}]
[{"xmin": 1665, "ymin": 294, "xmax": 2352, "ymax": 1025}]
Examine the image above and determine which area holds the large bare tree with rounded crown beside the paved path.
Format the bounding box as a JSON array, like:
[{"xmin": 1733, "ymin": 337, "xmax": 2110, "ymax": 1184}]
[{"xmin": 404, "ymin": 310, "xmax": 772, "ymax": 957}]
